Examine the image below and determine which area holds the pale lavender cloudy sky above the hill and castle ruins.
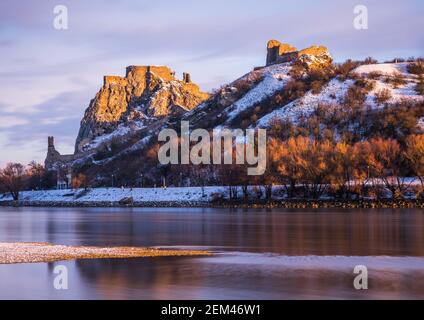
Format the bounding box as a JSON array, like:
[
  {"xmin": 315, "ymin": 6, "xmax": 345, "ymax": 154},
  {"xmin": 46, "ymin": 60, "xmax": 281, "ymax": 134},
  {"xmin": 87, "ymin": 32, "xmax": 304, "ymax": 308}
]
[{"xmin": 0, "ymin": 0, "xmax": 424, "ymax": 166}]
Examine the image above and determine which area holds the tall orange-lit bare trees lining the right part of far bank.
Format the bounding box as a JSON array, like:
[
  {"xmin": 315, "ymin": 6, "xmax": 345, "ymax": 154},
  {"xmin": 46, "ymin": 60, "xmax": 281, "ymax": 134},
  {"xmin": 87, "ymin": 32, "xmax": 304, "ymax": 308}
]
[{"xmin": 264, "ymin": 135, "xmax": 424, "ymax": 198}]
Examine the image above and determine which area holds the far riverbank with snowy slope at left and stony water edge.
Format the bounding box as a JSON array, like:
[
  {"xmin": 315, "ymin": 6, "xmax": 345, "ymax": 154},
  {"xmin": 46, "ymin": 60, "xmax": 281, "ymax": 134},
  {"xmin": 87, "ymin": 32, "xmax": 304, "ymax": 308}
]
[{"xmin": 0, "ymin": 187, "xmax": 424, "ymax": 209}]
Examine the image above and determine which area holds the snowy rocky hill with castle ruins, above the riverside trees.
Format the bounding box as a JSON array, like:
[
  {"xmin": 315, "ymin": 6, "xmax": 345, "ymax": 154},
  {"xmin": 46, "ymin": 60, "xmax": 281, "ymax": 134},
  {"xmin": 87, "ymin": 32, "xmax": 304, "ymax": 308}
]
[{"xmin": 44, "ymin": 40, "xmax": 424, "ymax": 185}]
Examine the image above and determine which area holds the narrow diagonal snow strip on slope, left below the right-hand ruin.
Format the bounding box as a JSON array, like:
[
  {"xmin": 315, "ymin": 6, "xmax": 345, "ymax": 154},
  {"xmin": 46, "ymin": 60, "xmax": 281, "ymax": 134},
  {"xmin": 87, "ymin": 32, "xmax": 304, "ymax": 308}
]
[{"xmin": 226, "ymin": 63, "xmax": 291, "ymax": 123}]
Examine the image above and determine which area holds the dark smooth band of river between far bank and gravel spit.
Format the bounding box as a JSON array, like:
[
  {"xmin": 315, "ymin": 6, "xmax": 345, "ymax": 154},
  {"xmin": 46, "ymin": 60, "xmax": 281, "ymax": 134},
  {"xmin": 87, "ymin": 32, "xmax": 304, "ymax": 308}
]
[{"xmin": 0, "ymin": 208, "xmax": 424, "ymax": 256}]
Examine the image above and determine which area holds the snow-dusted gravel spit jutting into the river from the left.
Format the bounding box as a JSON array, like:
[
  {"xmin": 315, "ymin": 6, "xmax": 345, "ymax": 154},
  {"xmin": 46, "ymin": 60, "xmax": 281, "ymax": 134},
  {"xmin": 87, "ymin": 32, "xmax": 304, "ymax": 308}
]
[{"xmin": 0, "ymin": 242, "xmax": 211, "ymax": 264}]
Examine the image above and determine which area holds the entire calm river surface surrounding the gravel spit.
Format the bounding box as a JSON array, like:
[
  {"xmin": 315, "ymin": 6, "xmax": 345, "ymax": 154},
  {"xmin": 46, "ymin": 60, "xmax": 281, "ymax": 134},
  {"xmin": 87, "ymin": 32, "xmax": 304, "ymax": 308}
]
[{"xmin": 0, "ymin": 208, "xmax": 424, "ymax": 299}]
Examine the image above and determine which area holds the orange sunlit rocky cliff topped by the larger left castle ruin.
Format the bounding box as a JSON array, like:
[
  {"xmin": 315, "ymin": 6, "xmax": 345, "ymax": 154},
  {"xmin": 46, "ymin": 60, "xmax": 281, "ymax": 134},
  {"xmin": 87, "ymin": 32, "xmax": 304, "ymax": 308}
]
[{"xmin": 75, "ymin": 66, "xmax": 208, "ymax": 153}]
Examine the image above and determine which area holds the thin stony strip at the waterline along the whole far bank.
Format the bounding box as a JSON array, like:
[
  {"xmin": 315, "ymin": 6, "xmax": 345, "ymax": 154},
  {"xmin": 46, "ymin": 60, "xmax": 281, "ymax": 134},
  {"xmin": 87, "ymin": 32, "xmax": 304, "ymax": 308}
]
[{"xmin": 0, "ymin": 199, "xmax": 424, "ymax": 209}]
